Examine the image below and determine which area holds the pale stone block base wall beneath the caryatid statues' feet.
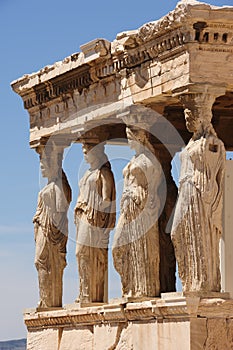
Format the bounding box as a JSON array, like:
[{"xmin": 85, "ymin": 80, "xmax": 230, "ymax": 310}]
[{"xmin": 24, "ymin": 293, "xmax": 233, "ymax": 350}]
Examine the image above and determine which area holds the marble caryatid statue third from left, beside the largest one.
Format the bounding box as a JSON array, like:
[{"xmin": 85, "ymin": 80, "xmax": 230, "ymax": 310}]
[{"xmin": 113, "ymin": 127, "xmax": 162, "ymax": 298}]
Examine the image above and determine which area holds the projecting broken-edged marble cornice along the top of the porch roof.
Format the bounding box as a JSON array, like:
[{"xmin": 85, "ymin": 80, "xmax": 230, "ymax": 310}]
[{"xmin": 12, "ymin": 0, "xmax": 233, "ymax": 110}]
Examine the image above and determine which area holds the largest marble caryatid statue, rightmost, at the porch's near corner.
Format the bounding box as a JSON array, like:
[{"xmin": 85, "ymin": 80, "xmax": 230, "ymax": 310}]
[{"xmin": 171, "ymin": 94, "xmax": 225, "ymax": 292}]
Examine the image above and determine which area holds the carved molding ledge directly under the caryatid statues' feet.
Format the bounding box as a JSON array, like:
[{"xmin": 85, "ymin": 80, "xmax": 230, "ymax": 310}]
[{"xmin": 24, "ymin": 293, "xmax": 233, "ymax": 330}]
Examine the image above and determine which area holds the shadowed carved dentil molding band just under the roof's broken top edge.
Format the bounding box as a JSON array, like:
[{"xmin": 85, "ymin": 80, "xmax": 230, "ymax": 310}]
[{"xmin": 21, "ymin": 21, "xmax": 233, "ymax": 109}]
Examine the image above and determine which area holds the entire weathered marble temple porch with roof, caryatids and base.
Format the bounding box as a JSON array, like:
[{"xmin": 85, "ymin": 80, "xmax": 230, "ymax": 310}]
[{"xmin": 12, "ymin": 0, "xmax": 233, "ymax": 350}]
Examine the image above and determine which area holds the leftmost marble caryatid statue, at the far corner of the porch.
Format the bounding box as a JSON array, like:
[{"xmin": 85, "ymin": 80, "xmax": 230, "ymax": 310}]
[{"xmin": 33, "ymin": 144, "xmax": 71, "ymax": 308}]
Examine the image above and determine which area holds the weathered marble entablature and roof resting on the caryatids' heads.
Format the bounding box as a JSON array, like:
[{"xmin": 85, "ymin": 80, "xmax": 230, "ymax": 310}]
[{"xmin": 12, "ymin": 0, "xmax": 233, "ymax": 149}]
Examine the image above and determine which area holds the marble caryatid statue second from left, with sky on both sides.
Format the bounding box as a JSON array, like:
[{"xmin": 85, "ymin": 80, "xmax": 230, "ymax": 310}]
[{"xmin": 74, "ymin": 141, "xmax": 116, "ymax": 303}]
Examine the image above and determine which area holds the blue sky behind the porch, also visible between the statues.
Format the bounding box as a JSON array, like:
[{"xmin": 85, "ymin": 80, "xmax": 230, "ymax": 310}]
[{"xmin": 0, "ymin": 0, "xmax": 233, "ymax": 340}]
